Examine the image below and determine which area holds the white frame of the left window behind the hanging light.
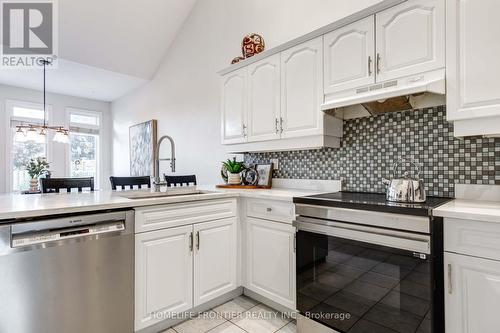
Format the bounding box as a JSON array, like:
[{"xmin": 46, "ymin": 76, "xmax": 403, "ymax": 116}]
[{"xmin": 5, "ymin": 99, "xmax": 52, "ymax": 193}]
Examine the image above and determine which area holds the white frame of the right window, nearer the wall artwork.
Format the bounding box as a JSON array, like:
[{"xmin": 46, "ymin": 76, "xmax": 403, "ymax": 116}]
[{"xmin": 65, "ymin": 106, "xmax": 103, "ymax": 189}]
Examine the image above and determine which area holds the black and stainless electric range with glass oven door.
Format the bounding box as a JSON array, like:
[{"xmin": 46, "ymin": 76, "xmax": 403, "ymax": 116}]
[{"xmin": 293, "ymin": 192, "xmax": 451, "ymax": 333}]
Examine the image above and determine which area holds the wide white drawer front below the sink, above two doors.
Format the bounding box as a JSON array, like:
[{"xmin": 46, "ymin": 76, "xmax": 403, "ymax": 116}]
[{"xmin": 135, "ymin": 199, "xmax": 236, "ymax": 233}]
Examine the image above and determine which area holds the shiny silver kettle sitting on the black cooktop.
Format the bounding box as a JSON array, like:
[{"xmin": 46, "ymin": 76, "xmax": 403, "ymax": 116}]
[{"xmin": 382, "ymin": 158, "xmax": 426, "ymax": 202}]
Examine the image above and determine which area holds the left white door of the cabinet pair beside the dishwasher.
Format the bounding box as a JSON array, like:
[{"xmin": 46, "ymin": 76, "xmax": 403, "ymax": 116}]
[{"xmin": 135, "ymin": 225, "xmax": 193, "ymax": 330}]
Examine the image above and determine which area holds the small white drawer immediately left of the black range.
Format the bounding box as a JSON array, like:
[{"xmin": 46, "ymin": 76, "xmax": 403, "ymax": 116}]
[{"xmin": 246, "ymin": 199, "xmax": 295, "ymax": 223}]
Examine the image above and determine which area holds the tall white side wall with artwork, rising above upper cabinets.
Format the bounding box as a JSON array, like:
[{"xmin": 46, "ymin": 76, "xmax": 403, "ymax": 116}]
[{"xmin": 112, "ymin": 0, "xmax": 380, "ymax": 184}]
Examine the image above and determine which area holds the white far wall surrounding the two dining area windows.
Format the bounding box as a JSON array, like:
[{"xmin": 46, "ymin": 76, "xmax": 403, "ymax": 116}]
[{"xmin": 0, "ymin": 83, "xmax": 111, "ymax": 192}]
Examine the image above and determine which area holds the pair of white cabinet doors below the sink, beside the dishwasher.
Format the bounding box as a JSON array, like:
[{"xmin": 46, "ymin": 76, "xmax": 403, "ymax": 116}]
[{"xmin": 135, "ymin": 201, "xmax": 239, "ymax": 331}]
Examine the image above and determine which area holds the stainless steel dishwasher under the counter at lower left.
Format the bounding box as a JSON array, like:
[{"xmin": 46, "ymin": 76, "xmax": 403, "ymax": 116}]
[{"xmin": 0, "ymin": 211, "xmax": 134, "ymax": 333}]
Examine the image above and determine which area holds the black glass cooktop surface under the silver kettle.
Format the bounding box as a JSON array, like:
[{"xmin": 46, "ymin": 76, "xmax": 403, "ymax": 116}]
[{"xmin": 293, "ymin": 192, "xmax": 452, "ymax": 216}]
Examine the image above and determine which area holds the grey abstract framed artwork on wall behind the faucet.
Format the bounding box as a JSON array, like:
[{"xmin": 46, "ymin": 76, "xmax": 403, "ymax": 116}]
[{"xmin": 129, "ymin": 120, "xmax": 158, "ymax": 176}]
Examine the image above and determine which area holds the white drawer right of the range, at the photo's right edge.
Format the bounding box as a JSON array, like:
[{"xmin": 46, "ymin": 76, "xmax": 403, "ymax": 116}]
[{"xmin": 444, "ymin": 218, "xmax": 500, "ymax": 260}]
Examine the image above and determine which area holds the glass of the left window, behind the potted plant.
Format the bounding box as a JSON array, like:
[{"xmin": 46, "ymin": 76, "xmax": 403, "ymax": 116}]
[{"xmin": 7, "ymin": 101, "xmax": 48, "ymax": 191}]
